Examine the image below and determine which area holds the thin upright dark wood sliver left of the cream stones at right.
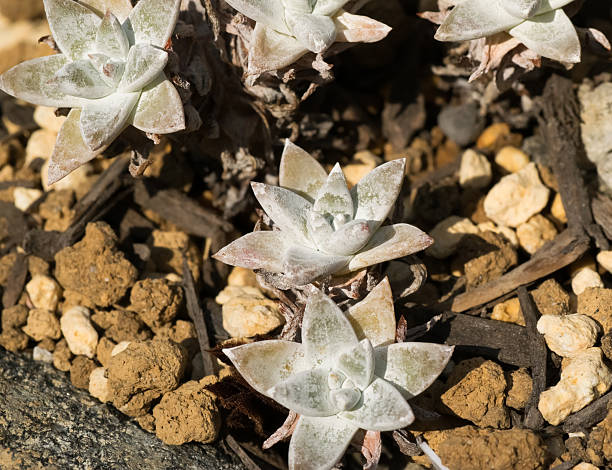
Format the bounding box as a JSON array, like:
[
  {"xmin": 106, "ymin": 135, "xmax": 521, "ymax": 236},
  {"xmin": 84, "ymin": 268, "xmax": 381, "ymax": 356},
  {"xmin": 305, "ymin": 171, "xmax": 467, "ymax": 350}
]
[{"xmin": 517, "ymin": 287, "xmax": 548, "ymax": 430}]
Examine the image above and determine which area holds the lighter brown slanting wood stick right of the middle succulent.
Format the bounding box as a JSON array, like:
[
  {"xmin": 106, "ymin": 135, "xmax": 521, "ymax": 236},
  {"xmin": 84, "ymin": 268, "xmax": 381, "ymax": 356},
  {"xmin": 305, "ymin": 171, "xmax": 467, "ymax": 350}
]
[{"xmin": 451, "ymin": 229, "xmax": 589, "ymax": 312}]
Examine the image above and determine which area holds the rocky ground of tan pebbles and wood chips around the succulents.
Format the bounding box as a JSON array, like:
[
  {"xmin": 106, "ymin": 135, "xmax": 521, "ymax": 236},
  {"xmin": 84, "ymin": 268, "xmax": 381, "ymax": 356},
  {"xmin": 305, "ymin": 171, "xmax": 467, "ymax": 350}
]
[{"xmin": 0, "ymin": 1, "xmax": 612, "ymax": 470}]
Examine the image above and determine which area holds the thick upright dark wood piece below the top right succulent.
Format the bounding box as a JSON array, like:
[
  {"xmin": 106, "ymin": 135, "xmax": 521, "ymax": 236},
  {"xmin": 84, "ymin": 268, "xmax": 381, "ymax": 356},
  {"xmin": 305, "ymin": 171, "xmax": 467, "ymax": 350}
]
[{"xmin": 540, "ymin": 74, "xmax": 610, "ymax": 250}]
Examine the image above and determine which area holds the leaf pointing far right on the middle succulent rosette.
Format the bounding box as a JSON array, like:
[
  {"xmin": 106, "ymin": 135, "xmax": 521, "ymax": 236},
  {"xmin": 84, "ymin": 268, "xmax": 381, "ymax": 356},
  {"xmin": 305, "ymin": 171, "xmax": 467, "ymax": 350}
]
[{"xmin": 347, "ymin": 224, "xmax": 433, "ymax": 272}]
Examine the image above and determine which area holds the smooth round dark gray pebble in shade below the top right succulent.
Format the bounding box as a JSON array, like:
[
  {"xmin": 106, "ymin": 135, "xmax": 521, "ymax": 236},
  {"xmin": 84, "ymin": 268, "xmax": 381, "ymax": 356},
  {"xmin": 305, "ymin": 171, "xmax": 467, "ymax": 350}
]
[{"xmin": 438, "ymin": 102, "xmax": 484, "ymax": 147}]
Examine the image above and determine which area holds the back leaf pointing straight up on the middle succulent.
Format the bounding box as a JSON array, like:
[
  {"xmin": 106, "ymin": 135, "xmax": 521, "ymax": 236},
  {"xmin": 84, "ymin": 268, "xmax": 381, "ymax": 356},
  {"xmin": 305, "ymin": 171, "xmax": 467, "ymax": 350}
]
[{"xmin": 278, "ymin": 139, "xmax": 327, "ymax": 202}]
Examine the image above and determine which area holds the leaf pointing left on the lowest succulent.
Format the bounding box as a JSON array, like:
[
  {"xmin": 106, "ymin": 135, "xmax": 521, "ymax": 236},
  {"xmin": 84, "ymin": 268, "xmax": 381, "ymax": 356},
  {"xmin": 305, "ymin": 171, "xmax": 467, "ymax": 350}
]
[{"xmin": 223, "ymin": 340, "xmax": 307, "ymax": 396}]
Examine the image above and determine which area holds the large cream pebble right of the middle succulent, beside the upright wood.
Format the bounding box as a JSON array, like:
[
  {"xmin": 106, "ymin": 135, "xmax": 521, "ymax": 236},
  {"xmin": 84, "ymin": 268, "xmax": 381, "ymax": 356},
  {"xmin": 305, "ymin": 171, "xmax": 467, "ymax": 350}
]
[{"xmin": 484, "ymin": 163, "xmax": 550, "ymax": 227}]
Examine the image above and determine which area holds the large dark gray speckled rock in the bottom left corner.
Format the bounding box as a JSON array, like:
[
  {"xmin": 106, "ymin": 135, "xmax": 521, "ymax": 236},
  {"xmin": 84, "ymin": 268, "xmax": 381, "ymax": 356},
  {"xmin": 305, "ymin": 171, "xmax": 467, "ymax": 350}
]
[{"xmin": 0, "ymin": 348, "xmax": 244, "ymax": 470}]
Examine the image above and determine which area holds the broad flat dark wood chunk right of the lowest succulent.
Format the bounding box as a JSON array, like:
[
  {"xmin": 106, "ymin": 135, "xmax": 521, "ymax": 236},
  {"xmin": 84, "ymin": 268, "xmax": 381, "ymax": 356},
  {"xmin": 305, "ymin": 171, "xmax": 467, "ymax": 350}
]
[{"xmin": 432, "ymin": 312, "xmax": 531, "ymax": 367}]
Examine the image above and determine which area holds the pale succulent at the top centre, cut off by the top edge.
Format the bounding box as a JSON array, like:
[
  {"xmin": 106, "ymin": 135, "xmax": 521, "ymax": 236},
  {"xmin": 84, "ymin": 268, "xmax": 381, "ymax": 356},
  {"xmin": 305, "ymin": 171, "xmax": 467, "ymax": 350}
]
[{"xmin": 226, "ymin": 0, "xmax": 391, "ymax": 74}]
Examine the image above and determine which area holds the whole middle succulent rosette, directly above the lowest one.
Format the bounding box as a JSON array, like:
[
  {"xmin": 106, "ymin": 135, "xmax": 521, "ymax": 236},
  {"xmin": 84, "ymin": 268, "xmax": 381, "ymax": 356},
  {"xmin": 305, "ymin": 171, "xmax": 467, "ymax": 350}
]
[{"xmin": 214, "ymin": 140, "xmax": 433, "ymax": 287}]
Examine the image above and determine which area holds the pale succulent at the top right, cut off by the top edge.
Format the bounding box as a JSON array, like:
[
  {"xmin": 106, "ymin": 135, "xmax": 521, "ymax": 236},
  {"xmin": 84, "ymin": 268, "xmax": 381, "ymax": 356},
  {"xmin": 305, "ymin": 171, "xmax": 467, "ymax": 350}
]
[{"xmin": 435, "ymin": 0, "xmax": 580, "ymax": 63}]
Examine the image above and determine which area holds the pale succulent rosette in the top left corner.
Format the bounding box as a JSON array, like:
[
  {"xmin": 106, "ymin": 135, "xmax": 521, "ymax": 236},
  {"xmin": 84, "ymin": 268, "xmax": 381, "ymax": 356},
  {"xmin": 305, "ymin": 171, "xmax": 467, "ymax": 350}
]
[{"xmin": 0, "ymin": 0, "xmax": 185, "ymax": 183}]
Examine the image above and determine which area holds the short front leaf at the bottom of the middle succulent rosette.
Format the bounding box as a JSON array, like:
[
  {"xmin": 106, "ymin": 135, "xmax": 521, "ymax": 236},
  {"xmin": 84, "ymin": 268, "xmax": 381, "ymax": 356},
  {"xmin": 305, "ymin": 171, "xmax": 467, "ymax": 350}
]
[{"xmin": 282, "ymin": 245, "xmax": 351, "ymax": 286}]
